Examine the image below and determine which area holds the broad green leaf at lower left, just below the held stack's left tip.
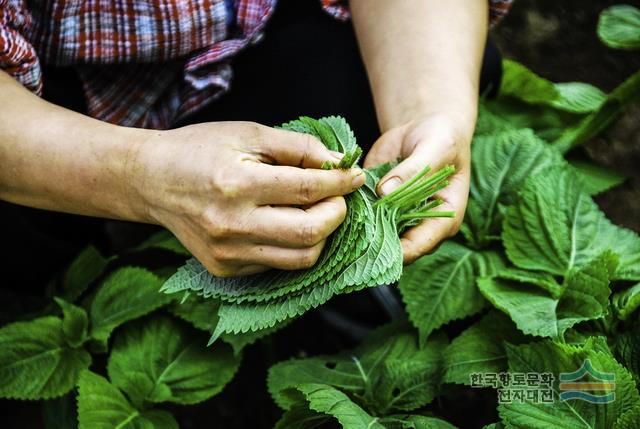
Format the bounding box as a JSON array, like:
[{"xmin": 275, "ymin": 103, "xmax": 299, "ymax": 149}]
[{"xmin": 108, "ymin": 317, "xmax": 240, "ymax": 404}]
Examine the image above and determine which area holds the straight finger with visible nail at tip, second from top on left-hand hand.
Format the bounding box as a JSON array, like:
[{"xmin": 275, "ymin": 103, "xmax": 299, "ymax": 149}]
[{"xmin": 253, "ymin": 165, "xmax": 365, "ymax": 205}]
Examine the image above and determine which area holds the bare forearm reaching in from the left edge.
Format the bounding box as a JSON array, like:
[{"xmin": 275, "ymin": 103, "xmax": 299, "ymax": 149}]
[{"xmin": 0, "ymin": 71, "xmax": 149, "ymax": 221}]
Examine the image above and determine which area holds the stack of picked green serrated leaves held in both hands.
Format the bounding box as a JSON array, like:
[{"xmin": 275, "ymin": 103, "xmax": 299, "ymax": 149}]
[{"xmin": 162, "ymin": 117, "xmax": 454, "ymax": 341}]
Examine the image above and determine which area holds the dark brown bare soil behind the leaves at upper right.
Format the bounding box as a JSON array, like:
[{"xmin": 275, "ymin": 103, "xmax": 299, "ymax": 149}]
[{"xmin": 493, "ymin": 0, "xmax": 640, "ymax": 232}]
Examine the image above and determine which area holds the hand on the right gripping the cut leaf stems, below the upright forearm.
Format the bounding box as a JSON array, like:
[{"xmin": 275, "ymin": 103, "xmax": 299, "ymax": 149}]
[{"xmin": 364, "ymin": 114, "xmax": 474, "ymax": 264}]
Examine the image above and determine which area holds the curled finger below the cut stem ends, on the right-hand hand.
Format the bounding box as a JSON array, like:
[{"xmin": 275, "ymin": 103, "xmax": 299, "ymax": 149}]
[{"xmin": 400, "ymin": 174, "xmax": 469, "ymax": 264}]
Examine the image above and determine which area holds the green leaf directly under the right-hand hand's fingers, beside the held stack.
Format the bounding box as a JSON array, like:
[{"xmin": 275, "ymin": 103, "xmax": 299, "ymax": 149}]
[{"xmin": 399, "ymin": 241, "xmax": 503, "ymax": 344}]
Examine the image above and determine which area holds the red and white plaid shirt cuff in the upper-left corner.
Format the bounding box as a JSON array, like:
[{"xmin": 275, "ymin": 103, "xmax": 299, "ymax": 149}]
[{"xmin": 0, "ymin": 0, "xmax": 42, "ymax": 95}]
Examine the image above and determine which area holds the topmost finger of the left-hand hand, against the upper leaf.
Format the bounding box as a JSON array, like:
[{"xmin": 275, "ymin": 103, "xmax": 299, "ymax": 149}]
[{"xmin": 260, "ymin": 128, "xmax": 342, "ymax": 168}]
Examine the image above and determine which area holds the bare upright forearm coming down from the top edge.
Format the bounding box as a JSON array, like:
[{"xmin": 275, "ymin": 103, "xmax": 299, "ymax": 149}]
[{"xmin": 350, "ymin": 0, "xmax": 488, "ymax": 133}]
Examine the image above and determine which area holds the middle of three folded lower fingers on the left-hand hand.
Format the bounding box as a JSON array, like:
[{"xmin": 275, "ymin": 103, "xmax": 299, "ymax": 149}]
[{"xmin": 248, "ymin": 197, "xmax": 347, "ymax": 248}]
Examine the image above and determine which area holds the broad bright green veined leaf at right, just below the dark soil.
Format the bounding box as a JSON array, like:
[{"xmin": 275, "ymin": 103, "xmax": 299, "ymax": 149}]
[{"xmin": 502, "ymin": 167, "xmax": 640, "ymax": 280}]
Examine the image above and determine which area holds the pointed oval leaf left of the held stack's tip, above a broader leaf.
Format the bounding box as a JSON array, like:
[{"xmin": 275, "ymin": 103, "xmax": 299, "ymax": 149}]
[{"xmin": 89, "ymin": 267, "xmax": 172, "ymax": 342}]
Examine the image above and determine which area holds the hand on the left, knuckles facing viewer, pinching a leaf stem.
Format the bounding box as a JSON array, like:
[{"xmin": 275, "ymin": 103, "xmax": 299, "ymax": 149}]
[{"xmin": 131, "ymin": 122, "xmax": 365, "ymax": 276}]
